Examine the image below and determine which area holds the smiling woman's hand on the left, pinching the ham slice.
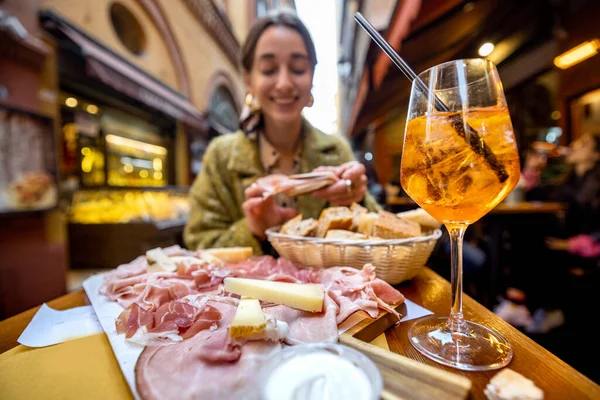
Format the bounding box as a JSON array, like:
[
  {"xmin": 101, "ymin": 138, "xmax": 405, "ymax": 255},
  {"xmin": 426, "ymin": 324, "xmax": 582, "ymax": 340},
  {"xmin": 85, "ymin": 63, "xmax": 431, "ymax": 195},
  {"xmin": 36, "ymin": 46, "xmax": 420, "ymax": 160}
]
[{"xmin": 242, "ymin": 183, "xmax": 297, "ymax": 240}]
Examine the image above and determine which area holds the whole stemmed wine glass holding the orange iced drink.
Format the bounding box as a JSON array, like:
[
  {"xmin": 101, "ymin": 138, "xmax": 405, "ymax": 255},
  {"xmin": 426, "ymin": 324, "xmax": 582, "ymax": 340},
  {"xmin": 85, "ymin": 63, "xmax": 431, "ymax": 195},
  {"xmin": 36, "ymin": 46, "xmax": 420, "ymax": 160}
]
[{"xmin": 400, "ymin": 59, "xmax": 520, "ymax": 371}]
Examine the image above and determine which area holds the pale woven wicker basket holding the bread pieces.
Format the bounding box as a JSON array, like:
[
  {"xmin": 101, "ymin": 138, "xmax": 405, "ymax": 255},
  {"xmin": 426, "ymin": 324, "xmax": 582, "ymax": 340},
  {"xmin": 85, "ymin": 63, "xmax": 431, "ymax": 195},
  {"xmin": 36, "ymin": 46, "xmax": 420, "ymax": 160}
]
[{"xmin": 266, "ymin": 227, "xmax": 442, "ymax": 285}]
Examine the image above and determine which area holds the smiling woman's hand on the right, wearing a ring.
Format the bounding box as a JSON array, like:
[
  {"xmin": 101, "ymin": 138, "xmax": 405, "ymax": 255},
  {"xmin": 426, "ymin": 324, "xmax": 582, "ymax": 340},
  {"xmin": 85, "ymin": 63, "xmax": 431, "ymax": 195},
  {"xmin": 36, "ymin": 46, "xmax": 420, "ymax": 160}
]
[{"xmin": 312, "ymin": 161, "xmax": 367, "ymax": 206}]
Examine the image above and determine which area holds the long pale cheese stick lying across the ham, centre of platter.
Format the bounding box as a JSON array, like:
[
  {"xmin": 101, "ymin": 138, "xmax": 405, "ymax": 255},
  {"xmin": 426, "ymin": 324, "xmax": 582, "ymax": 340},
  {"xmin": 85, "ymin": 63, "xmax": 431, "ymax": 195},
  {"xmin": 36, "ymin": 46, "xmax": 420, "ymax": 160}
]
[{"xmin": 225, "ymin": 278, "xmax": 324, "ymax": 312}]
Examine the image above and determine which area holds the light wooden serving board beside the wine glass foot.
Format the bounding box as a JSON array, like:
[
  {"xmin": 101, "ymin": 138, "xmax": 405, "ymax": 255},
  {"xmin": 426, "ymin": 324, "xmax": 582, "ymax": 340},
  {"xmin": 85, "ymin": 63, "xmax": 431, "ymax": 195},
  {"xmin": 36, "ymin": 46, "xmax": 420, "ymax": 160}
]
[{"xmin": 340, "ymin": 303, "xmax": 471, "ymax": 400}]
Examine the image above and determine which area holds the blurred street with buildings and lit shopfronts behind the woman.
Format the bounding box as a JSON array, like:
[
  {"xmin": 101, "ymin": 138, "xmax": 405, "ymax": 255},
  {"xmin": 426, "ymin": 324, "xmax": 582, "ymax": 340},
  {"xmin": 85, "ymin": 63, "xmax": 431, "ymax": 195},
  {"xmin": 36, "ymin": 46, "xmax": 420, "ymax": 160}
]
[{"xmin": 0, "ymin": 0, "xmax": 600, "ymax": 382}]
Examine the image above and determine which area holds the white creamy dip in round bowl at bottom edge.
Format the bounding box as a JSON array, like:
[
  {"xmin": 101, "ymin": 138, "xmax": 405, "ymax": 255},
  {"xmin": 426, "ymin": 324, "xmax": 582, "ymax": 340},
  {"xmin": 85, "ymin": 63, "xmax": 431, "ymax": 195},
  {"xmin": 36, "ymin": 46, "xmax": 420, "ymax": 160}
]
[{"xmin": 262, "ymin": 350, "xmax": 373, "ymax": 400}]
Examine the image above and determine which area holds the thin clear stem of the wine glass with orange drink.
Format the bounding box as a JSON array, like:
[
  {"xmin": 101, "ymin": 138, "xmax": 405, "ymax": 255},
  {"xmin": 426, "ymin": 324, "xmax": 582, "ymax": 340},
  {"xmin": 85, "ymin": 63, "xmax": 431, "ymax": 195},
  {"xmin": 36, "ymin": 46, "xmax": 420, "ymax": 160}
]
[{"xmin": 446, "ymin": 224, "xmax": 467, "ymax": 332}]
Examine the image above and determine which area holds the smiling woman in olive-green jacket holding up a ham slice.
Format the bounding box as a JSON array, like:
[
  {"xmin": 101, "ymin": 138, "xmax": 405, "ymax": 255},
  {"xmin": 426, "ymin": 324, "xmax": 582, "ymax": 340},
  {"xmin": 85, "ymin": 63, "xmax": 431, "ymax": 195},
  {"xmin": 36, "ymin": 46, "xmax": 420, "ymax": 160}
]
[{"xmin": 184, "ymin": 10, "xmax": 379, "ymax": 254}]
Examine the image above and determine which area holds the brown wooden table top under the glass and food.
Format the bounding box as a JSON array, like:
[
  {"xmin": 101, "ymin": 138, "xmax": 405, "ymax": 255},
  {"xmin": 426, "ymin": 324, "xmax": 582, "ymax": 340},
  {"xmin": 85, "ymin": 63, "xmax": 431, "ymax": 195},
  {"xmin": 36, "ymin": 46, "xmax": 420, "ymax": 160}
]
[{"xmin": 0, "ymin": 268, "xmax": 600, "ymax": 399}]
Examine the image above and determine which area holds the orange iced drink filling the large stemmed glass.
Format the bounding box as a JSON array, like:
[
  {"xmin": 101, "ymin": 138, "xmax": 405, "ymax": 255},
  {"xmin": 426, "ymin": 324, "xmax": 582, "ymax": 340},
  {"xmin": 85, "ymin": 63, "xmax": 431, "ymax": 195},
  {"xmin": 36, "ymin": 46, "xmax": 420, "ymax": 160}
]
[{"xmin": 401, "ymin": 106, "xmax": 519, "ymax": 224}]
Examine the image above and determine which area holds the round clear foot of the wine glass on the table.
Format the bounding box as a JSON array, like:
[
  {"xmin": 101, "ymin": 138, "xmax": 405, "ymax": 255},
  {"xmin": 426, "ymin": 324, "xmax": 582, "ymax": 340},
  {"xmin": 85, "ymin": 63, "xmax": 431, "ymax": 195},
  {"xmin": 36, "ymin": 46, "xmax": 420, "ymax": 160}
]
[{"xmin": 408, "ymin": 316, "xmax": 513, "ymax": 371}]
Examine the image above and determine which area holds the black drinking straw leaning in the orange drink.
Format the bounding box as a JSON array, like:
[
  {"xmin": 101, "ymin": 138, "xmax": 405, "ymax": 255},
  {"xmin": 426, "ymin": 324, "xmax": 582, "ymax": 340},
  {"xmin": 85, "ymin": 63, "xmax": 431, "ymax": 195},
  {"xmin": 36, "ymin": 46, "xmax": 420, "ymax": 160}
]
[{"xmin": 354, "ymin": 12, "xmax": 508, "ymax": 183}]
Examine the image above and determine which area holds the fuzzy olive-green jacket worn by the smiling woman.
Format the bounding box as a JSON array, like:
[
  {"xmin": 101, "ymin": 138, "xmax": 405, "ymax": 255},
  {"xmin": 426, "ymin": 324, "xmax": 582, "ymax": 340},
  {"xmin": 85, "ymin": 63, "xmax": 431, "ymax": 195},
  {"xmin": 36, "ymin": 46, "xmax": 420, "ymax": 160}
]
[{"xmin": 184, "ymin": 123, "xmax": 380, "ymax": 255}]
